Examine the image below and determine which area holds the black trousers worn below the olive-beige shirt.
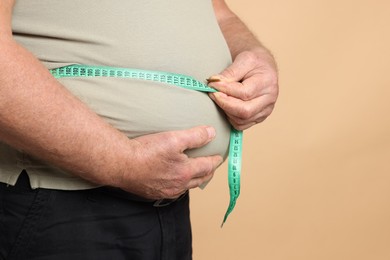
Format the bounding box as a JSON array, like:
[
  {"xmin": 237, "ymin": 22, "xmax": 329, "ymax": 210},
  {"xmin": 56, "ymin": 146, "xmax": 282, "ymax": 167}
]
[{"xmin": 0, "ymin": 172, "xmax": 192, "ymax": 260}]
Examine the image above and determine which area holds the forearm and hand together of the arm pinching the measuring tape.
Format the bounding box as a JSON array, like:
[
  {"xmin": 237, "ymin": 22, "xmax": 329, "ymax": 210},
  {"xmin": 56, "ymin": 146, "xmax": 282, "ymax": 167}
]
[{"xmin": 210, "ymin": 0, "xmax": 278, "ymax": 130}]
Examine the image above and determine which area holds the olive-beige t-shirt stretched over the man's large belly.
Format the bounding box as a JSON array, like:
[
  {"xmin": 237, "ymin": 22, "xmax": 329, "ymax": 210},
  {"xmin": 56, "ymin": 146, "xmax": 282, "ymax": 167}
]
[{"xmin": 0, "ymin": 0, "xmax": 231, "ymax": 190}]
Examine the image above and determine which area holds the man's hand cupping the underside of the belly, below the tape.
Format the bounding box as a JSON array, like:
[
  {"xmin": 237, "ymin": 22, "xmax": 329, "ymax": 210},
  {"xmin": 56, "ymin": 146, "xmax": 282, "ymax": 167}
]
[{"xmin": 116, "ymin": 126, "xmax": 222, "ymax": 199}]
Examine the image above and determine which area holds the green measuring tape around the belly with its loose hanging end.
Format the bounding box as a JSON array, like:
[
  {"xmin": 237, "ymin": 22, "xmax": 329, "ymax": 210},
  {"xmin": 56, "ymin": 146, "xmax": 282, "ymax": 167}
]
[{"xmin": 50, "ymin": 65, "xmax": 243, "ymax": 226}]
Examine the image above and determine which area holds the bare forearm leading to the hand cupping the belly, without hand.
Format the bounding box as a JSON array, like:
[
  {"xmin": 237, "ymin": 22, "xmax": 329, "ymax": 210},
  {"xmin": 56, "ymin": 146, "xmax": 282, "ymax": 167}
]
[{"xmin": 0, "ymin": 39, "xmax": 131, "ymax": 187}]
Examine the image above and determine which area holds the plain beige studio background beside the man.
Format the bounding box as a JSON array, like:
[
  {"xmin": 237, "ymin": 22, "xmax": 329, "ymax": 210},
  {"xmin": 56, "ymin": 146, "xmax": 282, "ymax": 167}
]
[{"xmin": 191, "ymin": 0, "xmax": 390, "ymax": 260}]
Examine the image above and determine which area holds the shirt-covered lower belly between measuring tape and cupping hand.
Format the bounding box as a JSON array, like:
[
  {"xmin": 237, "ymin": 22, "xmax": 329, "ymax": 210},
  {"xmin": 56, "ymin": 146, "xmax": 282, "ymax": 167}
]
[{"xmin": 60, "ymin": 78, "xmax": 230, "ymax": 158}]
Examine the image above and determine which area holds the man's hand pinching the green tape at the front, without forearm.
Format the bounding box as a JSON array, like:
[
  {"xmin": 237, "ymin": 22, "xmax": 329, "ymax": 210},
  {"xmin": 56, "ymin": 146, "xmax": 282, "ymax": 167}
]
[{"xmin": 209, "ymin": 48, "xmax": 278, "ymax": 130}]
